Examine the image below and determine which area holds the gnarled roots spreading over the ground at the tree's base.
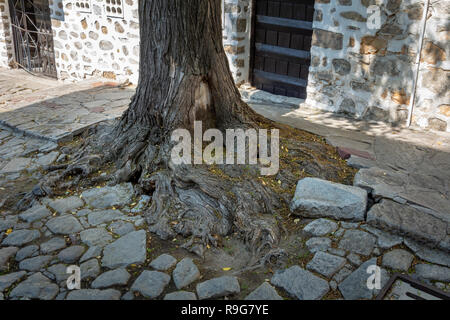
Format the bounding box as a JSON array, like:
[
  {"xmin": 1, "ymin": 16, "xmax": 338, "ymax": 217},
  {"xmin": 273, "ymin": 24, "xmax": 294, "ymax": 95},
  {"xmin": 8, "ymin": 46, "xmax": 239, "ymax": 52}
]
[{"xmin": 14, "ymin": 118, "xmax": 354, "ymax": 271}]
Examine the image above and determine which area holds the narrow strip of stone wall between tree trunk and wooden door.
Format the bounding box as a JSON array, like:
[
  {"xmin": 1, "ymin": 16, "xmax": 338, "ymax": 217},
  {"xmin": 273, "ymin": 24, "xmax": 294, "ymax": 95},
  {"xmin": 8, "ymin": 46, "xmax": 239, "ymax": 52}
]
[{"xmin": 222, "ymin": 0, "xmax": 251, "ymax": 85}]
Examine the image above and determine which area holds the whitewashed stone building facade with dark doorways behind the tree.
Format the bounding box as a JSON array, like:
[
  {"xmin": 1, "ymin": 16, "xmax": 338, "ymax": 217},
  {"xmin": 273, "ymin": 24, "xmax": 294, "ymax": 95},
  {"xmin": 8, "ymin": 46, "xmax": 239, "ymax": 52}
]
[{"xmin": 0, "ymin": 0, "xmax": 450, "ymax": 132}]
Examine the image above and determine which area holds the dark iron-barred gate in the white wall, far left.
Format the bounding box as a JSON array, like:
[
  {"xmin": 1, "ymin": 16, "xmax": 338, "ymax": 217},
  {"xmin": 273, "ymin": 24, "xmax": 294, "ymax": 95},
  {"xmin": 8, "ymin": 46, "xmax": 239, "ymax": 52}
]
[{"xmin": 9, "ymin": 0, "xmax": 56, "ymax": 78}]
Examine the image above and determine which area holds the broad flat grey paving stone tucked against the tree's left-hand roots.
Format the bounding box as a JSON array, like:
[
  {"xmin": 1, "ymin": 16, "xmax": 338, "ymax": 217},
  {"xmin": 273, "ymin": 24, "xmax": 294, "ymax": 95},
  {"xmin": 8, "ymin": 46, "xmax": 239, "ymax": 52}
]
[{"xmin": 82, "ymin": 183, "xmax": 134, "ymax": 209}]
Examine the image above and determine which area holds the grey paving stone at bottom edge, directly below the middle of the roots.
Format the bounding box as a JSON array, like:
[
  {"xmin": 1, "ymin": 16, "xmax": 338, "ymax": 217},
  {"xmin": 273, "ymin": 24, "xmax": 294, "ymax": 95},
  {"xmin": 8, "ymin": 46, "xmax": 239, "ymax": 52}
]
[{"xmin": 196, "ymin": 276, "xmax": 241, "ymax": 300}]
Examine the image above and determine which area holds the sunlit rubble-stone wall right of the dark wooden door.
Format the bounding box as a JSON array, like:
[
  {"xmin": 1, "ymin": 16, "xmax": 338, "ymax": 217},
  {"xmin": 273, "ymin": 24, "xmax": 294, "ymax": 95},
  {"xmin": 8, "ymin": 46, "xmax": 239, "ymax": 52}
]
[{"xmin": 306, "ymin": 0, "xmax": 450, "ymax": 131}]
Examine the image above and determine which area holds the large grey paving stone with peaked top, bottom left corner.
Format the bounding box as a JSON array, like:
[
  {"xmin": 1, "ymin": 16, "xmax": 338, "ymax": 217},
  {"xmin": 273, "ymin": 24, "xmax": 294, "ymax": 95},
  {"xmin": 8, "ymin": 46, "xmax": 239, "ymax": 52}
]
[{"xmin": 9, "ymin": 272, "xmax": 59, "ymax": 300}]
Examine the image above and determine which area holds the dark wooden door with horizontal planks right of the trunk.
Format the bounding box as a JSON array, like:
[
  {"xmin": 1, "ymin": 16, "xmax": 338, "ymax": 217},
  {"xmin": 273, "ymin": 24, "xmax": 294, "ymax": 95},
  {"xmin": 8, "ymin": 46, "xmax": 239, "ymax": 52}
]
[{"xmin": 250, "ymin": 0, "xmax": 314, "ymax": 98}]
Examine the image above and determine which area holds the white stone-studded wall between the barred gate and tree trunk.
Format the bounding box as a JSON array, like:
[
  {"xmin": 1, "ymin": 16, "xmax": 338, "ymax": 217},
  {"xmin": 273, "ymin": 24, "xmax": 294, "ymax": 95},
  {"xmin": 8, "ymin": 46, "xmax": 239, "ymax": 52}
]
[{"xmin": 50, "ymin": 0, "xmax": 139, "ymax": 84}]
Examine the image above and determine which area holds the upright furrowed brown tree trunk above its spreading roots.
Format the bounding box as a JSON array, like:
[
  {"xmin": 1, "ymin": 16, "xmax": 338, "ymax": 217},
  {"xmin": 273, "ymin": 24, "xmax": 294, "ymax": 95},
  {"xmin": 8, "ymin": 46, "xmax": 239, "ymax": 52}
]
[{"xmin": 122, "ymin": 0, "xmax": 253, "ymax": 134}]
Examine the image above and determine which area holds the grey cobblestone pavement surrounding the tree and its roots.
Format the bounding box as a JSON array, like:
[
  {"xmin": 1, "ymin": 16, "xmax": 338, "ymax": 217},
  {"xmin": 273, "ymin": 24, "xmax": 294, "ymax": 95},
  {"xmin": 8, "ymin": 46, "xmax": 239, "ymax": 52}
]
[{"xmin": 0, "ymin": 72, "xmax": 450, "ymax": 300}]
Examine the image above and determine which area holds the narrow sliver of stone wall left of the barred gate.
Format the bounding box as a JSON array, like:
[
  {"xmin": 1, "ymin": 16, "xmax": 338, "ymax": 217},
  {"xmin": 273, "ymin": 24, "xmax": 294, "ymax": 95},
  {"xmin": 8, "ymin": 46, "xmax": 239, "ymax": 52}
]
[{"xmin": 0, "ymin": 0, "xmax": 13, "ymax": 67}]
